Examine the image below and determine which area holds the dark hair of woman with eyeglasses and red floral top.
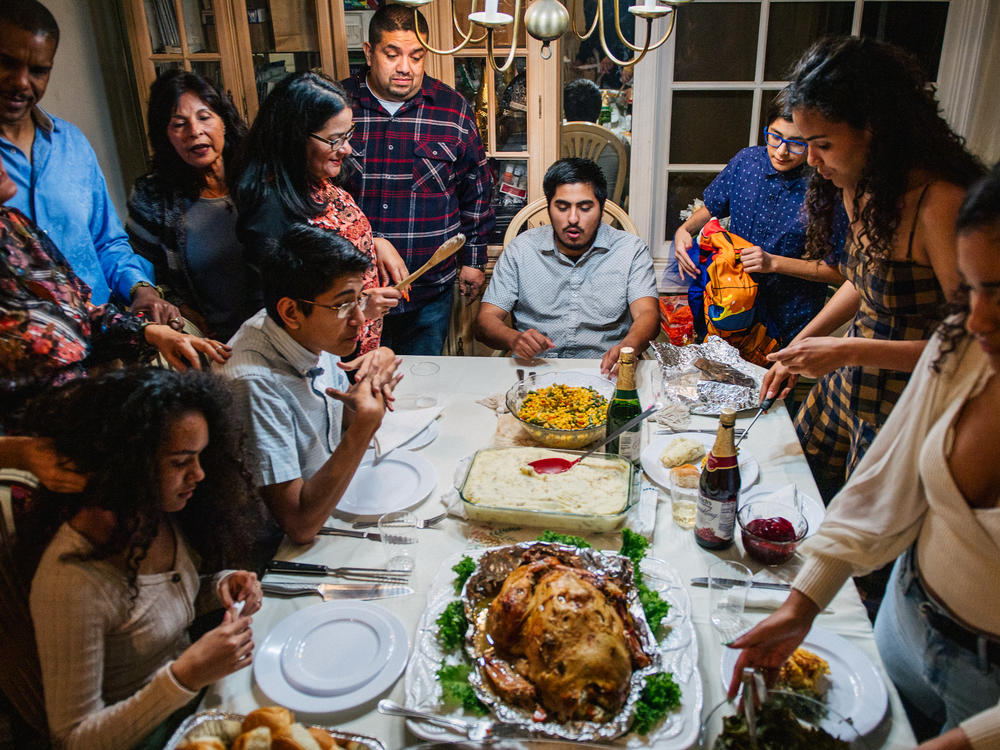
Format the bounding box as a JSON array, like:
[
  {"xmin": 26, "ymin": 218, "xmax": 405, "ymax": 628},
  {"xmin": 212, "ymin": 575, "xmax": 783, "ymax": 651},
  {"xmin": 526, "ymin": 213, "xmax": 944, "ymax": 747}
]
[{"xmin": 233, "ymin": 73, "xmax": 351, "ymax": 220}]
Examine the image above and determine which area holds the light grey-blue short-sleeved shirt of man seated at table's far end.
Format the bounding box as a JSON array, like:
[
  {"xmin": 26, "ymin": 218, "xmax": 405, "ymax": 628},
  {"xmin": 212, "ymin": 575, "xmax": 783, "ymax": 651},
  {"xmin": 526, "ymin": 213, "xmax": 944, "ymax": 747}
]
[{"xmin": 483, "ymin": 222, "xmax": 656, "ymax": 359}]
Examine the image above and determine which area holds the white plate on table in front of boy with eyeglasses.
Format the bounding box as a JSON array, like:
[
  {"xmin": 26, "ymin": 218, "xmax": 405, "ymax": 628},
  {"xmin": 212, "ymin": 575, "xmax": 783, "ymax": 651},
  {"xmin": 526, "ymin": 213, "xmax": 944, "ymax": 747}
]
[{"xmin": 337, "ymin": 448, "xmax": 437, "ymax": 516}]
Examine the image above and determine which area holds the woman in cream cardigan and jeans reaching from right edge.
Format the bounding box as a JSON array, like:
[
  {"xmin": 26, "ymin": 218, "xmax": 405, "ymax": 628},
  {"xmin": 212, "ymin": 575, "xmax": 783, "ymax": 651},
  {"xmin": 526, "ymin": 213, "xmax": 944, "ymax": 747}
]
[{"xmin": 731, "ymin": 165, "xmax": 1000, "ymax": 750}]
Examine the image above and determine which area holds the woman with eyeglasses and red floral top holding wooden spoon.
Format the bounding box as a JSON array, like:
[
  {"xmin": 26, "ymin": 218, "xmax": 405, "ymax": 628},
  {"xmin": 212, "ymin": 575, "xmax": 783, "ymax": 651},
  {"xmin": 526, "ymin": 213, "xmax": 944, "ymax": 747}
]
[{"xmin": 235, "ymin": 73, "xmax": 408, "ymax": 354}]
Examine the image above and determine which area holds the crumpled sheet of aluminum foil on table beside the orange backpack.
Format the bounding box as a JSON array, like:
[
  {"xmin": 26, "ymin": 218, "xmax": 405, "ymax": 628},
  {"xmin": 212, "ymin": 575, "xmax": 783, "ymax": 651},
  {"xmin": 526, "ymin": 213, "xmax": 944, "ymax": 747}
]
[{"xmin": 653, "ymin": 336, "xmax": 765, "ymax": 416}]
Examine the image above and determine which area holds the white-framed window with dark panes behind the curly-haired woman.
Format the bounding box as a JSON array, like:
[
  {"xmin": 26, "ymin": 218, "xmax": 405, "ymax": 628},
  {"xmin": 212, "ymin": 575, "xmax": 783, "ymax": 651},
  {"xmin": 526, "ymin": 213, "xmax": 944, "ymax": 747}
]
[{"xmin": 631, "ymin": 0, "xmax": 983, "ymax": 282}]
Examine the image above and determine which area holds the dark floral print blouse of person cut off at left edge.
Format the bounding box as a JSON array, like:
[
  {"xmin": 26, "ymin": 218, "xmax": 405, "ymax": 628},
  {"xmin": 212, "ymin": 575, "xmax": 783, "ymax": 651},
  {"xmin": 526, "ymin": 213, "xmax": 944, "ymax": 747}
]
[{"xmin": 0, "ymin": 206, "xmax": 152, "ymax": 434}]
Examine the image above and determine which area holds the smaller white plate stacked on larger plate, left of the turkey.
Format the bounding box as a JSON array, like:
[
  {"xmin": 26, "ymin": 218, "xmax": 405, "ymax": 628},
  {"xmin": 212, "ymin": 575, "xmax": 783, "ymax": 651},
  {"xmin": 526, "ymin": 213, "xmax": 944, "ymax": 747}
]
[{"xmin": 281, "ymin": 606, "xmax": 396, "ymax": 695}]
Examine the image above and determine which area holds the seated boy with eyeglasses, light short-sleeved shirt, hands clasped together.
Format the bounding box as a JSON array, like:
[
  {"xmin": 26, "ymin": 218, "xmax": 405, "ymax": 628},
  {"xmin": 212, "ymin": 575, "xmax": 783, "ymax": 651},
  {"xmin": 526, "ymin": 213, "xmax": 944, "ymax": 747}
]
[{"xmin": 220, "ymin": 224, "xmax": 400, "ymax": 544}]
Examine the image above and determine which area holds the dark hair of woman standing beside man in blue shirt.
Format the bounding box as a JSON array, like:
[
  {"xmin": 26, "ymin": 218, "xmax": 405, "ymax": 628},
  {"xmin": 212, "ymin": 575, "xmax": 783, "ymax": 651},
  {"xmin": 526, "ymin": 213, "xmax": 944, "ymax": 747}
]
[{"xmin": 146, "ymin": 69, "xmax": 247, "ymax": 198}]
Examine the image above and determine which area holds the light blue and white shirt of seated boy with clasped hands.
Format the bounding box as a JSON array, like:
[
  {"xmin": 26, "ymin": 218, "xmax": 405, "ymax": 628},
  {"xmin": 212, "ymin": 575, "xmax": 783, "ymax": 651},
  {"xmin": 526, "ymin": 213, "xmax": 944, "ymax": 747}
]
[{"xmin": 219, "ymin": 310, "xmax": 349, "ymax": 486}]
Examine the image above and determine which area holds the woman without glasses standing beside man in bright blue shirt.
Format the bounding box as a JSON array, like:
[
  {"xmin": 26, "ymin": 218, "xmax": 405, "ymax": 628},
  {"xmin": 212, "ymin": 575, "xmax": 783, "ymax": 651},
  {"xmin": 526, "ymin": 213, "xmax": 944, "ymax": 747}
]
[{"xmin": 126, "ymin": 70, "xmax": 261, "ymax": 341}]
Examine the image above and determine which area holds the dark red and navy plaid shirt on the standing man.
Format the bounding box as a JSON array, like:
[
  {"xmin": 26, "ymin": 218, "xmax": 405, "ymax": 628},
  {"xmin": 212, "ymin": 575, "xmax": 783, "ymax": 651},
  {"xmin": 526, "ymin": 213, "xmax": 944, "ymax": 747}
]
[{"xmin": 343, "ymin": 70, "xmax": 494, "ymax": 312}]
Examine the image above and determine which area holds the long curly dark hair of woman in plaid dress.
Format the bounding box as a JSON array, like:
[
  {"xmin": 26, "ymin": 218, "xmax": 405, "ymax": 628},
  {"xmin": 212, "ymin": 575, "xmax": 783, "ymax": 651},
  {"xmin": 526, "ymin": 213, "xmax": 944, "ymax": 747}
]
[{"xmin": 787, "ymin": 37, "xmax": 983, "ymax": 266}]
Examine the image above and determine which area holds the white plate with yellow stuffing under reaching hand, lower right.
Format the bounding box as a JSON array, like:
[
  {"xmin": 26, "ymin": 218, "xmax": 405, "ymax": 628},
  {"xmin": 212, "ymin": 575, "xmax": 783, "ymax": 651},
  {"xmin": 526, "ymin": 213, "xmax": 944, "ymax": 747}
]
[{"xmin": 722, "ymin": 627, "xmax": 889, "ymax": 735}]
